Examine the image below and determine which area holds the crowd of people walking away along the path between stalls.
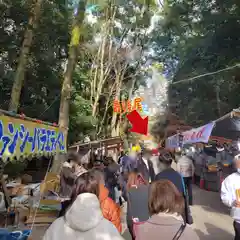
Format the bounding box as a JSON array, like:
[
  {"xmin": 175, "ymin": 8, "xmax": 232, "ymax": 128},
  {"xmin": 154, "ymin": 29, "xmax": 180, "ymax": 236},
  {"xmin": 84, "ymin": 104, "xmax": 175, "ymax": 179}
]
[{"xmin": 43, "ymin": 148, "xmax": 199, "ymax": 240}]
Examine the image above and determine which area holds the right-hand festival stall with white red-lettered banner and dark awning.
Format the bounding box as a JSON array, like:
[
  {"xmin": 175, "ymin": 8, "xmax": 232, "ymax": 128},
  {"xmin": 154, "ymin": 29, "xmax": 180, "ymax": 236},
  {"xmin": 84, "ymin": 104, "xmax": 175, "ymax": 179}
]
[{"xmin": 166, "ymin": 109, "xmax": 240, "ymax": 191}]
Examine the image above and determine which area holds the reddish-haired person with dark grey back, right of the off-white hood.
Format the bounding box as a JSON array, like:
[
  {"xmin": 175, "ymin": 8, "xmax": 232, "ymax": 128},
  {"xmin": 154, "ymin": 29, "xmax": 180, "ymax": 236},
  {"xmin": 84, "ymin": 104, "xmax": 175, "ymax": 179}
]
[{"xmin": 123, "ymin": 171, "xmax": 149, "ymax": 239}]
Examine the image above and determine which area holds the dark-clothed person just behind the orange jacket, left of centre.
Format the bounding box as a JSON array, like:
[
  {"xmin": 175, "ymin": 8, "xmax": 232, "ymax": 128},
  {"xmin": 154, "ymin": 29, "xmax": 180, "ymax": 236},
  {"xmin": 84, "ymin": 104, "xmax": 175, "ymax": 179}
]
[{"xmin": 104, "ymin": 157, "xmax": 120, "ymax": 202}]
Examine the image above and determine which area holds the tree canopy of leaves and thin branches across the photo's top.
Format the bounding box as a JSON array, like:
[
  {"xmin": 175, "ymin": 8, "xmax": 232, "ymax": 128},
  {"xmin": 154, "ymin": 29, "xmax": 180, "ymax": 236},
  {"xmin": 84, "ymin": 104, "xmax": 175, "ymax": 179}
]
[{"xmin": 0, "ymin": 0, "xmax": 240, "ymax": 146}]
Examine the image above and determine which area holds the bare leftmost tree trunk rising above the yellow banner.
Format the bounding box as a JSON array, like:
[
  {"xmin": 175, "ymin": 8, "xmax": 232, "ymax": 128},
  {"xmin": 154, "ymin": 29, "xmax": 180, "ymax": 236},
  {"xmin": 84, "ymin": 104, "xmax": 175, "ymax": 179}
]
[{"xmin": 9, "ymin": 0, "xmax": 43, "ymax": 112}]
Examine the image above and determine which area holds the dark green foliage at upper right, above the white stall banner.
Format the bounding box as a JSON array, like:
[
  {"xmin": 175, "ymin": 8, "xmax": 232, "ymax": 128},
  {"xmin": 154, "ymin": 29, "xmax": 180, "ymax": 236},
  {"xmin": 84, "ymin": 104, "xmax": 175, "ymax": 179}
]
[{"xmin": 153, "ymin": 0, "xmax": 240, "ymax": 126}]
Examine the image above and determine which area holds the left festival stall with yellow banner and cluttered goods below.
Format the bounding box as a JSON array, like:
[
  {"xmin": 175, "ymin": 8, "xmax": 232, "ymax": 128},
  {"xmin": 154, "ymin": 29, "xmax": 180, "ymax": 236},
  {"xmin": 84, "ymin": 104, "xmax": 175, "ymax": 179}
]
[{"xmin": 0, "ymin": 110, "xmax": 66, "ymax": 240}]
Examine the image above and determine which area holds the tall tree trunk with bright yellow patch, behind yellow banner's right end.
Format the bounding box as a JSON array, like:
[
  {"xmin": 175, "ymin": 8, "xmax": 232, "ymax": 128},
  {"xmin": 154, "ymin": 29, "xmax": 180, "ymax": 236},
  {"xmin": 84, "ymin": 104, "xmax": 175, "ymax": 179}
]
[{"xmin": 52, "ymin": 0, "xmax": 87, "ymax": 173}]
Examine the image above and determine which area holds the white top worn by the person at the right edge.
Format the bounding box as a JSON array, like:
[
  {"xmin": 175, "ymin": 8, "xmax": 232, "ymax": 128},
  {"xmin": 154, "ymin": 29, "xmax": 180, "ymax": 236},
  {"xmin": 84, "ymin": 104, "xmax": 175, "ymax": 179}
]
[{"xmin": 221, "ymin": 172, "xmax": 240, "ymax": 222}]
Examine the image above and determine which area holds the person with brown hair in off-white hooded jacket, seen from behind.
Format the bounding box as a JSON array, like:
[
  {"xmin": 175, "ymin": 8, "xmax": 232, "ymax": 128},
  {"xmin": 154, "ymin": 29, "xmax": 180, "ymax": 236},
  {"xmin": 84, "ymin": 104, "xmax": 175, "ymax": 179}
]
[{"xmin": 43, "ymin": 172, "xmax": 123, "ymax": 240}]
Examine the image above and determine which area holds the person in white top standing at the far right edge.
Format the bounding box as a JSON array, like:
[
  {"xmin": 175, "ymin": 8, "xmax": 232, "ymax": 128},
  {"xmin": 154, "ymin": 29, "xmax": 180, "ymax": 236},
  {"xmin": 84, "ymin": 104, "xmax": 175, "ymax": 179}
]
[{"xmin": 221, "ymin": 154, "xmax": 240, "ymax": 240}]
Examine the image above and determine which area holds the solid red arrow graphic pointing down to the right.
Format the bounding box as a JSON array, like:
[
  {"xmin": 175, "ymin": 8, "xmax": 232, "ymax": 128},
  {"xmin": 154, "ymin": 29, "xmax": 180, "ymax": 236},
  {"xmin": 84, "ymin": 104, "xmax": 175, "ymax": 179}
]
[{"xmin": 127, "ymin": 110, "xmax": 148, "ymax": 135}]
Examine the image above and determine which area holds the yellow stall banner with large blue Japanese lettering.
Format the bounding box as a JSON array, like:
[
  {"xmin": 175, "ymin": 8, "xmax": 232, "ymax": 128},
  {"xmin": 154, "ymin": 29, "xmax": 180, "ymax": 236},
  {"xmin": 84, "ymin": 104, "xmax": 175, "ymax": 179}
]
[{"xmin": 0, "ymin": 115, "xmax": 66, "ymax": 161}]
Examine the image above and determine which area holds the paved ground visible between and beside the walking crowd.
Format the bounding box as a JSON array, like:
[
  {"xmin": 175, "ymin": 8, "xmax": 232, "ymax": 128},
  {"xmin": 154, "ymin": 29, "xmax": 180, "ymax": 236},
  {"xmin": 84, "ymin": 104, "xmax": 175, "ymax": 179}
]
[{"xmin": 32, "ymin": 186, "xmax": 233, "ymax": 240}]
